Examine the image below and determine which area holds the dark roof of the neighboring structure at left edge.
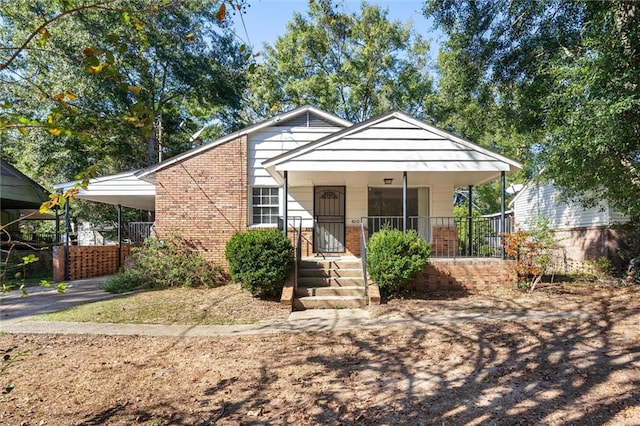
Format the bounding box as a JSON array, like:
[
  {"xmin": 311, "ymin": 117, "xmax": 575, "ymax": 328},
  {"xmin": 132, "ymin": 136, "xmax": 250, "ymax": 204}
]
[{"xmin": 0, "ymin": 158, "xmax": 49, "ymax": 209}]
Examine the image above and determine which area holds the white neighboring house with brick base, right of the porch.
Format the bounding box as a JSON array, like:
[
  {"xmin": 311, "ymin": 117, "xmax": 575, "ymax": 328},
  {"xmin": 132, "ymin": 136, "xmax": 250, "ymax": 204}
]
[{"xmin": 509, "ymin": 179, "xmax": 629, "ymax": 272}]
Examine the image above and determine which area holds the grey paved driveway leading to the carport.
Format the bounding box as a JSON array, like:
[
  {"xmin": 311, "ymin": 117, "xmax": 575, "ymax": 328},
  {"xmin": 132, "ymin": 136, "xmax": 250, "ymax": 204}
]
[{"xmin": 0, "ymin": 276, "xmax": 115, "ymax": 324}]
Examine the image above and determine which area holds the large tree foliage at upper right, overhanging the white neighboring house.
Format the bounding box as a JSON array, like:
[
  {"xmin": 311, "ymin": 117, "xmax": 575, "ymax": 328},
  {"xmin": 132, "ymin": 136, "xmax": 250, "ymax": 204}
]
[{"xmin": 425, "ymin": 0, "xmax": 640, "ymax": 214}]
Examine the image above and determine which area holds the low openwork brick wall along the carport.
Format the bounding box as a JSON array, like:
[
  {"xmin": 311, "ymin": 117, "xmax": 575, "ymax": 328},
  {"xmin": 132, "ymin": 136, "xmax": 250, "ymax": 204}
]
[{"xmin": 53, "ymin": 244, "xmax": 131, "ymax": 282}]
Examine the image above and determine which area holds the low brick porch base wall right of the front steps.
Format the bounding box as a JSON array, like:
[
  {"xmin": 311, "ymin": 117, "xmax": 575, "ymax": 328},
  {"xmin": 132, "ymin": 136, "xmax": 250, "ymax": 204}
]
[{"xmin": 415, "ymin": 258, "xmax": 515, "ymax": 293}]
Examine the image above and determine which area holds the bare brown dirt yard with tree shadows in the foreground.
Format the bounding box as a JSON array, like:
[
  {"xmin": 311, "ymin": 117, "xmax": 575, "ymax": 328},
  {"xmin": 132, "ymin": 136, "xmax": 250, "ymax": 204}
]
[{"xmin": 0, "ymin": 285, "xmax": 640, "ymax": 425}]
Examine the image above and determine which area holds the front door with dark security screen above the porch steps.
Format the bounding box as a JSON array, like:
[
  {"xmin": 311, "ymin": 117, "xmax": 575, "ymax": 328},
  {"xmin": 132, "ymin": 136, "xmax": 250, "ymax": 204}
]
[{"xmin": 313, "ymin": 186, "xmax": 346, "ymax": 253}]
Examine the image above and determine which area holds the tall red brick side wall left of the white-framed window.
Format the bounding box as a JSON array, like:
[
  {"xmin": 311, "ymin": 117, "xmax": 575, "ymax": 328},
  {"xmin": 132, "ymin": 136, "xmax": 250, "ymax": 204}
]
[{"xmin": 154, "ymin": 136, "xmax": 248, "ymax": 268}]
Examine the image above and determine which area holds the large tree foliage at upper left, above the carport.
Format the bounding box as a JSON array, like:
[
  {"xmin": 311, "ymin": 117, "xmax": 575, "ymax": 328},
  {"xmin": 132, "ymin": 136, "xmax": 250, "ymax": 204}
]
[{"xmin": 0, "ymin": 0, "xmax": 245, "ymax": 185}]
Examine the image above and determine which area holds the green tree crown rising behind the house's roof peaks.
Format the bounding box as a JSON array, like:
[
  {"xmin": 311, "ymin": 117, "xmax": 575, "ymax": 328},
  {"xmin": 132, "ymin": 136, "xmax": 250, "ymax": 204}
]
[{"xmin": 249, "ymin": 0, "xmax": 433, "ymax": 122}]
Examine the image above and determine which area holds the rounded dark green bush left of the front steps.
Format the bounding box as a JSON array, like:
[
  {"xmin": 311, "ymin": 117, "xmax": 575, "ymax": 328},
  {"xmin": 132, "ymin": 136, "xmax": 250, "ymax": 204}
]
[{"xmin": 224, "ymin": 229, "xmax": 293, "ymax": 296}]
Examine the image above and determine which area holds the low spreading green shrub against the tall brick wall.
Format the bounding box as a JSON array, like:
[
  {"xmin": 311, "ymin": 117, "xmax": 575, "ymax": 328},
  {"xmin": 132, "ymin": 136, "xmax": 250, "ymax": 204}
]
[{"xmin": 104, "ymin": 235, "xmax": 226, "ymax": 293}]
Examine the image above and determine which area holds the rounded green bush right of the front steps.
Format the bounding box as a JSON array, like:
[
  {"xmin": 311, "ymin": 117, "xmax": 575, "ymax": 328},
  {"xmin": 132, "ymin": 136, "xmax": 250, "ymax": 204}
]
[{"xmin": 367, "ymin": 228, "xmax": 431, "ymax": 292}]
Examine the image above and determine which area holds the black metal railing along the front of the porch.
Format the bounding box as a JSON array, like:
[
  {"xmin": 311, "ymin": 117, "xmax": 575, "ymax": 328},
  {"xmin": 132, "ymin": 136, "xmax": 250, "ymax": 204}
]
[{"xmin": 361, "ymin": 216, "xmax": 512, "ymax": 257}]
